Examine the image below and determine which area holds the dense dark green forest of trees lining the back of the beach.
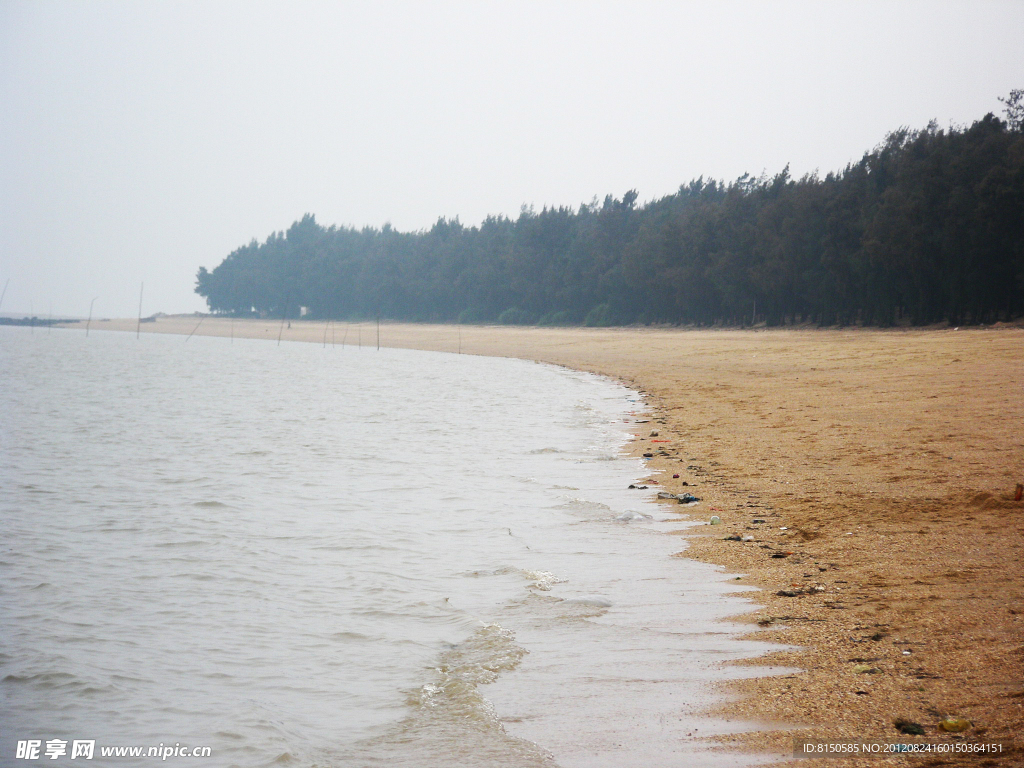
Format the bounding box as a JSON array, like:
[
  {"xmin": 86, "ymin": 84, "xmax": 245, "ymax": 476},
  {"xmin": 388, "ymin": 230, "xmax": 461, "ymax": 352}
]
[{"xmin": 196, "ymin": 104, "xmax": 1024, "ymax": 327}]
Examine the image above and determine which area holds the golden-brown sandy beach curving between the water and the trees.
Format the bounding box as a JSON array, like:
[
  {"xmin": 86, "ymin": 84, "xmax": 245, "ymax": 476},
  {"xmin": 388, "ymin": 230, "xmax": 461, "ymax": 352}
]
[{"xmin": 77, "ymin": 316, "xmax": 1024, "ymax": 766}]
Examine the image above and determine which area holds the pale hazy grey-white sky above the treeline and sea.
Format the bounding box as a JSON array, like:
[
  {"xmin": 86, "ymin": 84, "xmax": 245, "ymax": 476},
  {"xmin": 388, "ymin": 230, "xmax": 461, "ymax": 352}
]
[{"xmin": 0, "ymin": 0, "xmax": 1024, "ymax": 316}]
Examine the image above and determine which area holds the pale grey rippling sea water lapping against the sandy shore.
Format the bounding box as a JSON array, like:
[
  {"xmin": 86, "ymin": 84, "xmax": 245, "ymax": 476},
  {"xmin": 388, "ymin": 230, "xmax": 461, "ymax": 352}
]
[{"xmin": 0, "ymin": 328, "xmax": 778, "ymax": 768}]
